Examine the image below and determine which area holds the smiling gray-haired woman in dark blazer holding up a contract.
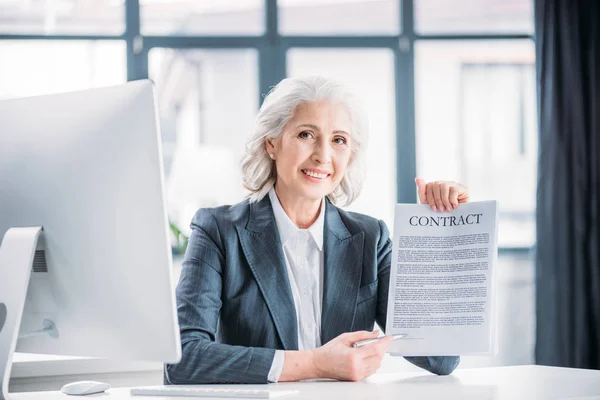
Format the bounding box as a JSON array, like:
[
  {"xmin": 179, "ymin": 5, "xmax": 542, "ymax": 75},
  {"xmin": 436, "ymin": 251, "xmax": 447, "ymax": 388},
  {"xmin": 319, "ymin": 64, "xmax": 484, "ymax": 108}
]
[{"xmin": 165, "ymin": 77, "xmax": 468, "ymax": 384}]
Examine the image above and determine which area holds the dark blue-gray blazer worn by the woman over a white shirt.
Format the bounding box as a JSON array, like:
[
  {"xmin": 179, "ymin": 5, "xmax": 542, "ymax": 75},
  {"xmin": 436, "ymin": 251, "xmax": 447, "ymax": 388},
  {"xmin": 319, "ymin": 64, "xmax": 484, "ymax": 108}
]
[{"xmin": 164, "ymin": 196, "xmax": 460, "ymax": 384}]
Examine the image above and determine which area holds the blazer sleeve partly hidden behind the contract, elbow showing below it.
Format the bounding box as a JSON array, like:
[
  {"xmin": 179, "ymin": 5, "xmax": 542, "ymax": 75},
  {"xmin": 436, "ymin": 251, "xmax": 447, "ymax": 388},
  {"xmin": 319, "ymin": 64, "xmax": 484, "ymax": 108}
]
[{"xmin": 375, "ymin": 221, "xmax": 460, "ymax": 375}]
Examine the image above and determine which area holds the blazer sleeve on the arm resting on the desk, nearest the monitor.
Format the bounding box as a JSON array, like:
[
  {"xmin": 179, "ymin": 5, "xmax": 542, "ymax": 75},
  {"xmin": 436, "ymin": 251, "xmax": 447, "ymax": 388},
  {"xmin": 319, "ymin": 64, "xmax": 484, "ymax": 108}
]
[{"xmin": 164, "ymin": 209, "xmax": 275, "ymax": 384}]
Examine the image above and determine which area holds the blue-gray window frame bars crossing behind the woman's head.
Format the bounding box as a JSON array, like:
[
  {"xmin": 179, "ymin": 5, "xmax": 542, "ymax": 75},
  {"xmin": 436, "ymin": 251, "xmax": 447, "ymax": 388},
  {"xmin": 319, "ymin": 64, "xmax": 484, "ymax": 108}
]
[{"xmin": 0, "ymin": 0, "xmax": 534, "ymax": 222}]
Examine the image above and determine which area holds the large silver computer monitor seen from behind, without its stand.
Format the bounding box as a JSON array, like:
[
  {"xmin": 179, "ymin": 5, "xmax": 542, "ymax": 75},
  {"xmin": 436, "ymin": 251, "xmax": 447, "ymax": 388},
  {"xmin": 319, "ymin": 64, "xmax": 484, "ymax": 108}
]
[{"xmin": 0, "ymin": 80, "xmax": 181, "ymax": 366}]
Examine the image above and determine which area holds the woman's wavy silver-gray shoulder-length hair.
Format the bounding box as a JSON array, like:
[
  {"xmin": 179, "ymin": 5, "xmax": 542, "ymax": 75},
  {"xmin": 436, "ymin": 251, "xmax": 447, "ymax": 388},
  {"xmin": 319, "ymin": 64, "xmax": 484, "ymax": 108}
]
[{"xmin": 242, "ymin": 76, "xmax": 368, "ymax": 206}]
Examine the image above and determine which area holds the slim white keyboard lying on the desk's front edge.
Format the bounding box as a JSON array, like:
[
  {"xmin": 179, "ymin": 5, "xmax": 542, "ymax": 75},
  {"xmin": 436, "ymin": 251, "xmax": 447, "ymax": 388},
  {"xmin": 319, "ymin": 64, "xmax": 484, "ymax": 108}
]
[{"xmin": 131, "ymin": 385, "xmax": 298, "ymax": 399}]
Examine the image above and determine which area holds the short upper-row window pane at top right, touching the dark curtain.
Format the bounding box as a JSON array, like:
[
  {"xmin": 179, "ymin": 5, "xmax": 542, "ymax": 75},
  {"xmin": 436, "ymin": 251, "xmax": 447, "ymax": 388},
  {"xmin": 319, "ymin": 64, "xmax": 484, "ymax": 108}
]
[{"xmin": 415, "ymin": 0, "xmax": 533, "ymax": 33}]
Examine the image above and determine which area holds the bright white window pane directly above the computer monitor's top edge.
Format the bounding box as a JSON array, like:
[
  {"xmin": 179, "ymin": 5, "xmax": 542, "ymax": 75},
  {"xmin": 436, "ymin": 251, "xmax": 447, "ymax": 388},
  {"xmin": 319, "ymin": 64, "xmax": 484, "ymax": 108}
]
[{"xmin": 0, "ymin": 40, "xmax": 127, "ymax": 99}]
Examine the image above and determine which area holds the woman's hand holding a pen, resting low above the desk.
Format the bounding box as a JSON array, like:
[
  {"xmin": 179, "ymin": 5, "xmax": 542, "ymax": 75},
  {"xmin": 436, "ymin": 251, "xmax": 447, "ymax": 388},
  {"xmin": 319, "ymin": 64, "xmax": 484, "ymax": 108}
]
[{"xmin": 313, "ymin": 331, "xmax": 392, "ymax": 382}]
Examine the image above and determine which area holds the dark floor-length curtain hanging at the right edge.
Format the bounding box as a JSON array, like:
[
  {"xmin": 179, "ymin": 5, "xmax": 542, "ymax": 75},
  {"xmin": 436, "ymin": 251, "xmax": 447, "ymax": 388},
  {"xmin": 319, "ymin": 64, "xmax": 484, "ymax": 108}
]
[{"xmin": 535, "ymin": 0, "xmax": 600, "ymax": 369}]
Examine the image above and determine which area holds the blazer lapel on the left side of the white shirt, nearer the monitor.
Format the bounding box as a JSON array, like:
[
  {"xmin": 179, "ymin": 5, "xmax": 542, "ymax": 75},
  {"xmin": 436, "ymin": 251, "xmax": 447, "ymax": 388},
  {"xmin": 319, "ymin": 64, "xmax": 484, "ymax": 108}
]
[{"xmin": 236, "ymin": 196, "xmax": 298, "ymax": 350}]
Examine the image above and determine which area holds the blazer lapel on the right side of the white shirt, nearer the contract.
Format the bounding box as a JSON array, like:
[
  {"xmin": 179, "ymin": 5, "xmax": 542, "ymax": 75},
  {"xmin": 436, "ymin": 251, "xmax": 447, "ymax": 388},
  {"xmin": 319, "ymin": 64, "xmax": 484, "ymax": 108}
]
[{"xmin": 321, "ymin": 199, "xmax": 365, "ymax": 344}]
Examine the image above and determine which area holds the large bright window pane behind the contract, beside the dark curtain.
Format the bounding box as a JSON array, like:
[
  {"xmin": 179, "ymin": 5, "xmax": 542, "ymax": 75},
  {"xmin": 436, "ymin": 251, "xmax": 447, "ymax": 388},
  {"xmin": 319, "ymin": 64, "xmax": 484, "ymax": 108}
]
[{"xmin": 415, "ymin": 40, "xmax": 537, "ymax": 247}]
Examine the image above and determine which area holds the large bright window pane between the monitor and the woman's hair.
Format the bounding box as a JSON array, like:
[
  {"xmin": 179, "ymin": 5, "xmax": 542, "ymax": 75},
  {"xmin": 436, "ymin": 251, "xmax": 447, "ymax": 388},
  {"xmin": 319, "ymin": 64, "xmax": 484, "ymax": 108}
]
[{"xmin": 149, "ymin": 49, "xmax": 259, "ymax": 234}]
